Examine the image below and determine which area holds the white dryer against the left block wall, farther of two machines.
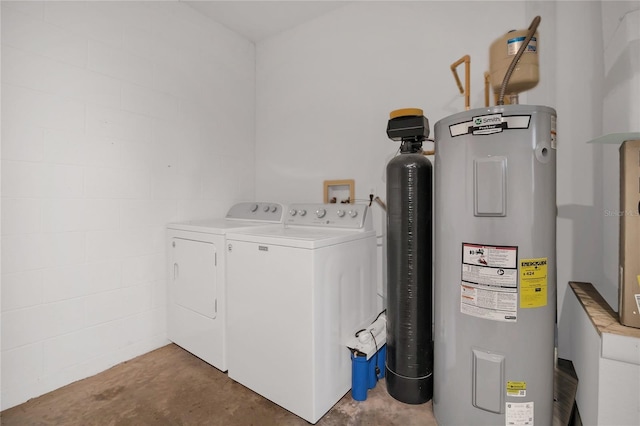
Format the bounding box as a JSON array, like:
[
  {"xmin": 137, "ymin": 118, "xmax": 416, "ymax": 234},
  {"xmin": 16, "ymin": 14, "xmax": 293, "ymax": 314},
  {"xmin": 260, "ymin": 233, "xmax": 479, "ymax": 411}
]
[{"xmin": 167, "ymin": 202, "xmax": 284, "ymax": 371}]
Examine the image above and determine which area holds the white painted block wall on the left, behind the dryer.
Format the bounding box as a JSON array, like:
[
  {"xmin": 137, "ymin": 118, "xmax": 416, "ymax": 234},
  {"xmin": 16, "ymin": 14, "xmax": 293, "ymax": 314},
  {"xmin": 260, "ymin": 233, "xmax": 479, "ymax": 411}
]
[{"xmin": 1, "ymin": 1, "xmax": 255, "ymax": 409}]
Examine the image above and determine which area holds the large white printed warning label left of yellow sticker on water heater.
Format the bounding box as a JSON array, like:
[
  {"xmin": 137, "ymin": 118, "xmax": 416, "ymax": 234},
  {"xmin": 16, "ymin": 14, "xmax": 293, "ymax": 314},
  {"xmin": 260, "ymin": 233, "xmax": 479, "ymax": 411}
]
[{"xmin": 460, "ymin": 243, "xmax": 518, "ymax": 322}]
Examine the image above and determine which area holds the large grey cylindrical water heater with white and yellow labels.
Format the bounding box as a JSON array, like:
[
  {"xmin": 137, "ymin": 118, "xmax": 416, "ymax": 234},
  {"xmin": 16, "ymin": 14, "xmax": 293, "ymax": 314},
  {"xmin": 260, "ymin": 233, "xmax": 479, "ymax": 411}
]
[{"xmin": 433, "ymin": 105, "xmax": 556, "ymax": 426}]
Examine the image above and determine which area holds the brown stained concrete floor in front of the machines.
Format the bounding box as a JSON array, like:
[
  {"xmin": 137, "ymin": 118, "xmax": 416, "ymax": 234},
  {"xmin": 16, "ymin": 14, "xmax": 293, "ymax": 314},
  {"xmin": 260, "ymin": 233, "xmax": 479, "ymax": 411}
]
[{"xmin": 0, "ymin": 344, "xmax": 437, "ymax": 426}]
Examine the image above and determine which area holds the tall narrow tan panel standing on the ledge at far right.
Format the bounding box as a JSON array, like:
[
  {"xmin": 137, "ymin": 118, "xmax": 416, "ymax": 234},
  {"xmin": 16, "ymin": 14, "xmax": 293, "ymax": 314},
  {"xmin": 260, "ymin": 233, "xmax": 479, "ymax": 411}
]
[{"xmin": 619, "ymin": 140, "xmax": 640, "ymax": 328}]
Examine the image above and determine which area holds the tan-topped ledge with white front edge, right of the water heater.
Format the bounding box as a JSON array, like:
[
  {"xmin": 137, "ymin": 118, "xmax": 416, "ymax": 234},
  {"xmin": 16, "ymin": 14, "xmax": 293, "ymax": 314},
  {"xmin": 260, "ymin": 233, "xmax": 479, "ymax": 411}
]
[{"xmin": 569, "ymin": 282, "xmax": 640, "ymax": 365}]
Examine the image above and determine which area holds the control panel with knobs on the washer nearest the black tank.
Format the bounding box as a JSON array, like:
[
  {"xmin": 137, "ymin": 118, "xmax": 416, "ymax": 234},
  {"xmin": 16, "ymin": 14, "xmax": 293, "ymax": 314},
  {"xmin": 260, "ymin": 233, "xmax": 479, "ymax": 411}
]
[{"xmin": 285, "ymin": 204, "xmax": 370, "ymax": 230}]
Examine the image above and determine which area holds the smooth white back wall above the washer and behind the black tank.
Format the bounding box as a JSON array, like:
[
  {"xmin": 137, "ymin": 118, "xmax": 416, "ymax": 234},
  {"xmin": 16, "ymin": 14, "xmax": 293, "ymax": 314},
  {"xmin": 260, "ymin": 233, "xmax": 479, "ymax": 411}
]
[{"xmin": 256, "ymin": 2, "xmax": 528, "ymax": 206}]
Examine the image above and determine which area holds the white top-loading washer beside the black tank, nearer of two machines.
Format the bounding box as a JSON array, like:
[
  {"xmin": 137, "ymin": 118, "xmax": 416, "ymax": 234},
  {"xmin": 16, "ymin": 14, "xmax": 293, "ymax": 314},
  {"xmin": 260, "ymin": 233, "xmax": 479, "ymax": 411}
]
[{"xmin": 227, "ymin": 204, "xmax": 377, "ymax": 423}]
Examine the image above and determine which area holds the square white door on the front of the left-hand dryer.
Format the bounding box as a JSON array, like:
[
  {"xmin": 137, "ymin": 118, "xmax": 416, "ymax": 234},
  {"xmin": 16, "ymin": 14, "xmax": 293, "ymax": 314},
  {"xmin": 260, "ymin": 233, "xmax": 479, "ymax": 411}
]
[{"xmin": 171, "ymin": 237, "xmax": 218, "ymax": 318}]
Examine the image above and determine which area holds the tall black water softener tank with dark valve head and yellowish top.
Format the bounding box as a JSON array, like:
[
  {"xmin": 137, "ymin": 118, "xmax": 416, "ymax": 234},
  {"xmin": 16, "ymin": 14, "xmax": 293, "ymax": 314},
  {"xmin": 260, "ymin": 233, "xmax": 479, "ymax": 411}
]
[{"xmin": 386, "ymin": 108, "xmax": 433, "ymax": 404}]
